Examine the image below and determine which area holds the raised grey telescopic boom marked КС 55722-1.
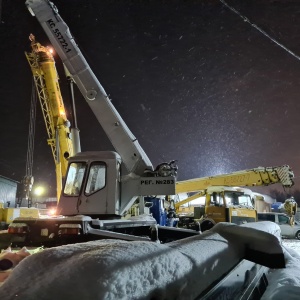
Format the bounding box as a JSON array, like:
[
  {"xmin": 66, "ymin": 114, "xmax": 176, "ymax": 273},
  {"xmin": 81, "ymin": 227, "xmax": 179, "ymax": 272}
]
[{"xmin": 26, "ymin": 0, "xmax": 153, "ymax": 175}]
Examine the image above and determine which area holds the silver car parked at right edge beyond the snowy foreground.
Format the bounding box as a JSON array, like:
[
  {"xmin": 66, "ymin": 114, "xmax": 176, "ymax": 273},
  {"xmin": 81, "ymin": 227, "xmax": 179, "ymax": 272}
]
[{"xmin": 257, "ymin": 212, "xmax": 300, "ymax": 240}]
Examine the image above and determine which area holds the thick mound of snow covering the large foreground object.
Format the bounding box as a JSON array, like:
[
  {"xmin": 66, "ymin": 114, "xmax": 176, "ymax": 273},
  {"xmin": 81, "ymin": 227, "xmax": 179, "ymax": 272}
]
[{"xmin": 0, "ymin": 223, "xmax": 281, "ymax": 300}]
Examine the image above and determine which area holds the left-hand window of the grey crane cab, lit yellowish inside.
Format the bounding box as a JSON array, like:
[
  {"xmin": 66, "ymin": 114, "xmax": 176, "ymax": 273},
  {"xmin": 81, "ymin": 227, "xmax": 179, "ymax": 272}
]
[{"xmin": 64, "ymin": 162, "xmax": 86, "ymax": 196}]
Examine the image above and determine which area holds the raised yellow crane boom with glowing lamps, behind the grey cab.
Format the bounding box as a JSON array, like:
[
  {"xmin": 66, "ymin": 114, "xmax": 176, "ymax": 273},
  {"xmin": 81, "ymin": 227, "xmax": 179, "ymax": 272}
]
[{"xmin": 25, "ymin": 34, "xmax": 80, "ymax": 200}]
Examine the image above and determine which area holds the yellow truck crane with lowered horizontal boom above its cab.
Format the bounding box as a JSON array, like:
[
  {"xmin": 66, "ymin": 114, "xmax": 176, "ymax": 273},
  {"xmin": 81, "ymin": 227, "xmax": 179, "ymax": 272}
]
[{"xmin": 175, "ymin": 165, "xmax": 294, "ymax": 231}]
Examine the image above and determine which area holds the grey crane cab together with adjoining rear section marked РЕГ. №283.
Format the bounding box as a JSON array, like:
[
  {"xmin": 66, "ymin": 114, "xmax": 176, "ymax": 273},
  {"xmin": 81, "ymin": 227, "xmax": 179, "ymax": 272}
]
[{"xmin": 57, "ymin": 151, "xmax": 176, "ymax": 219}]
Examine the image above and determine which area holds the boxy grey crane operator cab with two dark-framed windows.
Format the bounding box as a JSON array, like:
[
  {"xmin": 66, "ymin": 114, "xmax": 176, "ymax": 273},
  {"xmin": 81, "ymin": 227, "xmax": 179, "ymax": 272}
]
[{"xmin": 57, "ymin": 151, "xmax": 121, "ymax": 217}]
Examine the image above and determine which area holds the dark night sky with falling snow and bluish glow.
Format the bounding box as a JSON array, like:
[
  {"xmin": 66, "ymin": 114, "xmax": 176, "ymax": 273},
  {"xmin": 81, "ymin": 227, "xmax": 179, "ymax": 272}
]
[{"xmin": 0, "ymin": 0, "xmax": 300, "ymax": 196}]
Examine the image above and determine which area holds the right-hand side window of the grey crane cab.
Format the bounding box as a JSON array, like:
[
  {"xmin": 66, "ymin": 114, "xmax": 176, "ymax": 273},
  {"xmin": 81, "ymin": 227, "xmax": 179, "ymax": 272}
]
[{"xmin": 85, "ymin": 162, "xmax": 106, "ymax": 194}]
